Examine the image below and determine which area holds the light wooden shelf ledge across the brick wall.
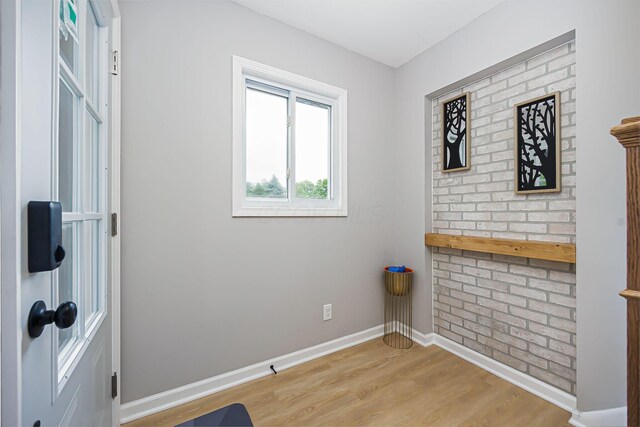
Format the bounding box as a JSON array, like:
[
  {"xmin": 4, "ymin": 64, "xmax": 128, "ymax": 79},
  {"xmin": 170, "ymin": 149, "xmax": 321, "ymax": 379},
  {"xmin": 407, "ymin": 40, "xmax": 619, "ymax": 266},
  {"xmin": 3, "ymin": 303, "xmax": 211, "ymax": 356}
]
[{"xmin": 424, "ymin": 233, "xmax": 576, "ymax": 264}]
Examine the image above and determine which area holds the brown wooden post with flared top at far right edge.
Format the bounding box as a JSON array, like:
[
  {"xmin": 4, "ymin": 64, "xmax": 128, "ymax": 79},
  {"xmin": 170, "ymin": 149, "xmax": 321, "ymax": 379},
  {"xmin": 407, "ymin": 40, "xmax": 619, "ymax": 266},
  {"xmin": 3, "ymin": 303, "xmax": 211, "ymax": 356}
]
[{"xmin": 611, "ymin": 117, "xmax": 640, "ymax": 426}]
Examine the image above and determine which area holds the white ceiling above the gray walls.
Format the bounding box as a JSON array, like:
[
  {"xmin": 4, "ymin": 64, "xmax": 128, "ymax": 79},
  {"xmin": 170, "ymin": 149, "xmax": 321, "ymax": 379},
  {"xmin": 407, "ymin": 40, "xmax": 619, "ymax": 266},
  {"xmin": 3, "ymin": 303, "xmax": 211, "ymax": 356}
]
[{"xmin": 232, "ymin": 0, "xmax": 502, "ymax": 67}]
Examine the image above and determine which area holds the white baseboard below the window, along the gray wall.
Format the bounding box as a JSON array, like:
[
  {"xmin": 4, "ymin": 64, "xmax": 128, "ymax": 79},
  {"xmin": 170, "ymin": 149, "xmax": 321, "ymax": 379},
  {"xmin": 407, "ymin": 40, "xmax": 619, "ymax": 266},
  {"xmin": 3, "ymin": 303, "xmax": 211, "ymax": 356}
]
[{"xmin": 120, "ymin": 325, "xmax": 383, "ymax": 424}]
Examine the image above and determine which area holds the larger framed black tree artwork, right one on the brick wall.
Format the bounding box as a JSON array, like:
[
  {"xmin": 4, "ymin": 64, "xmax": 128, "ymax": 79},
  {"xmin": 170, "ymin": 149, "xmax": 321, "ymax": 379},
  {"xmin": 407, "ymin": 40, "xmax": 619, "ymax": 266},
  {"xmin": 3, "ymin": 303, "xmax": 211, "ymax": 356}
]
[{"xmin": 514, "ymin": 92, "xmax": 561, "ymax": 194}]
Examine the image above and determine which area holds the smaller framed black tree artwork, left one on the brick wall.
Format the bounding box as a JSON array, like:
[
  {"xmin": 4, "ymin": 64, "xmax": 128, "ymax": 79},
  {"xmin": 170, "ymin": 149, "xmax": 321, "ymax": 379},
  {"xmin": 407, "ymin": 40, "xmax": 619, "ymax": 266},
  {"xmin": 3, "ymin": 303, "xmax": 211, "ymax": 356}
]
[{"xmin": 441, "ymin": 92, "xmax": 471, "ymax": 172}]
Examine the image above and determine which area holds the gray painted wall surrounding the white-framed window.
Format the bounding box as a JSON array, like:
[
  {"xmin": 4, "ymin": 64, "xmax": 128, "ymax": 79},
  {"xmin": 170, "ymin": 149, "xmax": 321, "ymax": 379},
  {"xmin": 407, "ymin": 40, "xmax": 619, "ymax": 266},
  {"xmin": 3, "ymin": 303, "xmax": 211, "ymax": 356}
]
[{"xmin": 120, "ymin": 1, "xmax": 394, "ymax": 403}]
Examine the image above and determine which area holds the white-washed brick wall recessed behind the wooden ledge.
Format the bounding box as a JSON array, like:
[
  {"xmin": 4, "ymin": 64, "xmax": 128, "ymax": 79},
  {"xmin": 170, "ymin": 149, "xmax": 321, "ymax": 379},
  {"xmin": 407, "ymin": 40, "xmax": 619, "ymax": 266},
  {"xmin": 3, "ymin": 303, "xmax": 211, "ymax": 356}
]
[{"xmin": 432, "ymin": 43, "xmax": 576, "ymax": 394}]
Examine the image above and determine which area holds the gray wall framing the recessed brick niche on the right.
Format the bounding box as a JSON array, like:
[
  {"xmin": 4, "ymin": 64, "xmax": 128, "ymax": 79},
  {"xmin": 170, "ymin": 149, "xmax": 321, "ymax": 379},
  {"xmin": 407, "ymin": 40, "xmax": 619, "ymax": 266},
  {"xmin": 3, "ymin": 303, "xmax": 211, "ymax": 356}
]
[{"xmin": 394, "ymin": 1, "xmax": 640, "ymax": 411}]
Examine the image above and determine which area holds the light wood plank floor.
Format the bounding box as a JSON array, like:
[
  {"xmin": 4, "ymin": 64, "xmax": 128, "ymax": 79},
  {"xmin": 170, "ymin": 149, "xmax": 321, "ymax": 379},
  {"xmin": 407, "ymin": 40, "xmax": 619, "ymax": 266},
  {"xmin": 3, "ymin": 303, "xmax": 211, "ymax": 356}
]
[{"xmin": 126, "ymin": 338, "xmax": 570, "ymax": 427}]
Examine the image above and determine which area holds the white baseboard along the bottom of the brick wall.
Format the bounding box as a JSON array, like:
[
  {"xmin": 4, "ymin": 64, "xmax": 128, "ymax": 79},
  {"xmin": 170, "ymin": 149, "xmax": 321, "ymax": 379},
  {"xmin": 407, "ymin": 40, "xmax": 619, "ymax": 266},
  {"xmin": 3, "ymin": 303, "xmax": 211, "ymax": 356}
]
[{"xmin": 434, "ymin": 334, "xmax": 576, "ymax": 412}]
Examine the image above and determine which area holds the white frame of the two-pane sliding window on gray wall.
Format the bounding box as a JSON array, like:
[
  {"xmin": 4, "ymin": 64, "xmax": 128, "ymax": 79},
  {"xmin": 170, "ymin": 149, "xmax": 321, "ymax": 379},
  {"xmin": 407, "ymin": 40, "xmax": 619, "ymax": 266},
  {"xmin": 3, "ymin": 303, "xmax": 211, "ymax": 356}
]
[{"xmin": 232, "ymin": 55, "xmax": 347, "ymax": 217}]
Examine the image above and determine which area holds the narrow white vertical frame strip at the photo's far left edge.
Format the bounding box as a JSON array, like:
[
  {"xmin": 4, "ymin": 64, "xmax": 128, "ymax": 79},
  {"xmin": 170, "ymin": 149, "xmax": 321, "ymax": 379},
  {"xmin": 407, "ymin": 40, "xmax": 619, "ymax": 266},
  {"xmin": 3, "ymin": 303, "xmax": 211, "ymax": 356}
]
[{"xmin": 0, "ymin": 0, "xmax": 22, "ymax": 425}]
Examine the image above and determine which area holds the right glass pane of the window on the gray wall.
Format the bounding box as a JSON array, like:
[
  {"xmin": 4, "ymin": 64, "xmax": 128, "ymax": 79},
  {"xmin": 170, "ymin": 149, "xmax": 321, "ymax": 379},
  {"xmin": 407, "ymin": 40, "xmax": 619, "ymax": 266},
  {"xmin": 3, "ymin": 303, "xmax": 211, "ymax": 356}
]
[{"xmin": 295, "ymin": 98, "xmax": 331, "ymax": 199}]
